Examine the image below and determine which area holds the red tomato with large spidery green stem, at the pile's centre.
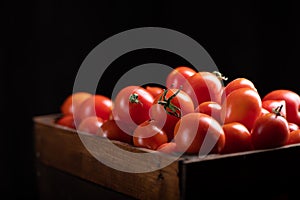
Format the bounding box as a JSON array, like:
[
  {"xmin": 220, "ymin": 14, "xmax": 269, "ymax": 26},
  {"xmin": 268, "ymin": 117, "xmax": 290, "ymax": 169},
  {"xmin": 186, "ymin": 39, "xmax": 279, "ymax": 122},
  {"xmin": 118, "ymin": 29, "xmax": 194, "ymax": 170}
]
[{"xmin": 150, "ymin": 89, "xmax": 194, "ymax": 141}]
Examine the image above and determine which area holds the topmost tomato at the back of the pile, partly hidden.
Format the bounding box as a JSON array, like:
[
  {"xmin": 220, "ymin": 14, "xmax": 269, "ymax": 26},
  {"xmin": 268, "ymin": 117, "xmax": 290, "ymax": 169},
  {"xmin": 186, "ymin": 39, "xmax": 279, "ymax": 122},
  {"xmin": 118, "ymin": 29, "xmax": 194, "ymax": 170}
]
[{"xmin": 166, "ymin": 66, "xmax": 196, "ymax": 89}]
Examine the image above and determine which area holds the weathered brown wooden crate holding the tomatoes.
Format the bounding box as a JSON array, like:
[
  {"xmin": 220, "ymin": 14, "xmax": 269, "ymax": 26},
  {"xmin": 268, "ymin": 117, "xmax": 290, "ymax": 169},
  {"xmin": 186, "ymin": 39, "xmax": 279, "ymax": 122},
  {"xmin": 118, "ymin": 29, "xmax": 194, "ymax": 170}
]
[{"xmin": 34, "ymin": 114, "xmax": 300, "ymax": 200}]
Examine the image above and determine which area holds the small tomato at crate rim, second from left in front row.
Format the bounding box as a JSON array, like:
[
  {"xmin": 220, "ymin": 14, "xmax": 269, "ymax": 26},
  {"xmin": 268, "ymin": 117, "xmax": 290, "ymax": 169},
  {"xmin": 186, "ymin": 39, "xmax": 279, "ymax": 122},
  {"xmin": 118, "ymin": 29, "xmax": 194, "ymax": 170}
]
[{"xmin": 77, "ymin": 116, "xmax": 103, "ymax": 134}]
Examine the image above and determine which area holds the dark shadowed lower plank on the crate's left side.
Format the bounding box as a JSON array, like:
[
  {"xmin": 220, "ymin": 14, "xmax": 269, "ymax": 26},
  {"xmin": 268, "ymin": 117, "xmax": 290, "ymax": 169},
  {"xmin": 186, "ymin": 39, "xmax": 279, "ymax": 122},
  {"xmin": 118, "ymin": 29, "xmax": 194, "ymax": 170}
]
[{"xmin": 36, "ymin": 161, "xmax": 135, "ymax": 200}]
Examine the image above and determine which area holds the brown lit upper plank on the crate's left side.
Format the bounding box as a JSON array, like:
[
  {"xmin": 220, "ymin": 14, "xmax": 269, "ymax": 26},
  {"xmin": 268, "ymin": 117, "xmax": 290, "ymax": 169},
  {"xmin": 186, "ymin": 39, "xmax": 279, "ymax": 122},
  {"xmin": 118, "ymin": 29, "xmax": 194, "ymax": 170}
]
[{"xmin": 34, "ymin": 115, "xmax": 180, "ymax": 199}]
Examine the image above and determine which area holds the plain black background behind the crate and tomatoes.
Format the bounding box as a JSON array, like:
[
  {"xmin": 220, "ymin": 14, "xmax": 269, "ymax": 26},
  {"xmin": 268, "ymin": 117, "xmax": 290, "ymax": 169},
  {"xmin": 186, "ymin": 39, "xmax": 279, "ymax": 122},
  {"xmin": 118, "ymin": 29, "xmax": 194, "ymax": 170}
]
[{"xmin": 0, "ymin": 0, "xmax": 300, "ymax": 199}]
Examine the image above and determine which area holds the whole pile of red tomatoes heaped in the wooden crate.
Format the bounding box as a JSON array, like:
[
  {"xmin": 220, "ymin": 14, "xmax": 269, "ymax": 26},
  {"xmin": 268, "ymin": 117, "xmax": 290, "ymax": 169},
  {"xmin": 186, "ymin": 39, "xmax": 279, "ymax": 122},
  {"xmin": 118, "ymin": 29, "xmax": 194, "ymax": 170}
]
[{"xmin": 56, "ymin": 66, "xmax": 300, "ymax": 155}]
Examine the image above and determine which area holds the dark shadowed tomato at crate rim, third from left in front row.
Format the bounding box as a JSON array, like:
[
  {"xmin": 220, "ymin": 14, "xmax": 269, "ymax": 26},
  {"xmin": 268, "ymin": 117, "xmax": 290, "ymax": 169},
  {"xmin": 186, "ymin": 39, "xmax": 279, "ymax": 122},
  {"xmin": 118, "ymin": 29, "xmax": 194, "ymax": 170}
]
[{"xmin": 97, "ymin": 119, "xmax": 132, "ymax": 144}]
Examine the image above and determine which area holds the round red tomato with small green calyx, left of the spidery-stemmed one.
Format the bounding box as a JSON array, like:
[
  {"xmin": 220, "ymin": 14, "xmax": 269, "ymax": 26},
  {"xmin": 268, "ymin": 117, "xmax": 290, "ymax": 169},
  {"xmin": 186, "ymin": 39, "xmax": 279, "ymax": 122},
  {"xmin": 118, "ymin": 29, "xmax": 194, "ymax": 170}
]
[{"xmin": 112, "ymin": 85, "xmax": 154, "ymax": 126}]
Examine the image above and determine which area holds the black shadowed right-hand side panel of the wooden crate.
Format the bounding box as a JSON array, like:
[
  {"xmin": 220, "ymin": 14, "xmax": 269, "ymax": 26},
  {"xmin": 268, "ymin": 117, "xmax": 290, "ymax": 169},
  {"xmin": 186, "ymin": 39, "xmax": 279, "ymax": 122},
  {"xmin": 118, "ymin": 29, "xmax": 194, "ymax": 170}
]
[{"xmin": 181, "ymin": 146, "xmax": 300, "ymax": 199}]
